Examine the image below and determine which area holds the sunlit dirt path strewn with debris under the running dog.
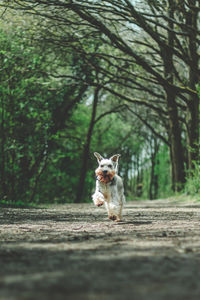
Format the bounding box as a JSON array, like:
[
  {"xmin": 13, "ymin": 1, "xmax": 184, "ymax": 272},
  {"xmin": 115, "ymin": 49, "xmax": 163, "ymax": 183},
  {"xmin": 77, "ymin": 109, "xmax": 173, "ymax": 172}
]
[{"xmin": 0, "ymin": 200, "xmax": 200, "ymax": 300}]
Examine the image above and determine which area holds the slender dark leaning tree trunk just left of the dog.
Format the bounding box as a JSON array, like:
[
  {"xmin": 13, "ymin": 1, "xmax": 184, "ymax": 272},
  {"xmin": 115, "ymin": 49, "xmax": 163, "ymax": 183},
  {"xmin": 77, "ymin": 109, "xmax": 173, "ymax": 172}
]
[{"xmin": 75, "ymin": 88, "xmax": 99, "ymax": 203}]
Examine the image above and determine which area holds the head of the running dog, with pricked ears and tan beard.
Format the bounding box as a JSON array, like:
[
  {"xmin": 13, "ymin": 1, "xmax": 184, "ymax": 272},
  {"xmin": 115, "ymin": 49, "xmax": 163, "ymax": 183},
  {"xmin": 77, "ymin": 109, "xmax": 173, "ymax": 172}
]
[{"xmin": 94, "ymin": 152, "xmax": 120, "ymax": 183}]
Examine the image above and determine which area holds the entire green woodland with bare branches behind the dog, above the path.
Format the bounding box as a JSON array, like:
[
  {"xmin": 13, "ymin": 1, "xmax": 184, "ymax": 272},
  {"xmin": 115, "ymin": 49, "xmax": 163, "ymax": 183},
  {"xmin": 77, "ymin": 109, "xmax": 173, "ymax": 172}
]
[{"xmin": 0, "ymin": 0, "xmax": 200, "ymax": 205}]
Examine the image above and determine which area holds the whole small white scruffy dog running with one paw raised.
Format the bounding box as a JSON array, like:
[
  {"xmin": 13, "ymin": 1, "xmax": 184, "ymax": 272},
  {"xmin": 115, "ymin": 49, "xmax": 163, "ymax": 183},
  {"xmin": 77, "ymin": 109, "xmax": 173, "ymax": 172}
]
[{"xmin": 92, "ymin": 152, "xmax": 125, "ymax": 222}]
